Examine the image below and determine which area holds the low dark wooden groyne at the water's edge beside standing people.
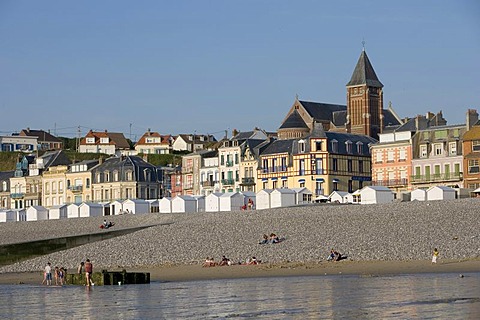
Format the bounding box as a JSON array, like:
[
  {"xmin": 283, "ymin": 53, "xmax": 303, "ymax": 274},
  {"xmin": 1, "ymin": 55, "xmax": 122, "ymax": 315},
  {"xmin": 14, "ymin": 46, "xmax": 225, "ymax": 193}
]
[{"xmin": 65, "ymin": 270, "xmax": 150, "ymax": 286}]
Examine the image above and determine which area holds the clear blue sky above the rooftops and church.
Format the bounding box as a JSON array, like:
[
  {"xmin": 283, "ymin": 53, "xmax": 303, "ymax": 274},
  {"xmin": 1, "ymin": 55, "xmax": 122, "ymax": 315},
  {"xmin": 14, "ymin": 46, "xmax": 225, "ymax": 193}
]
[{"xmin": 0, "ymin": 0, "xmax": 480, "ymax": 139}]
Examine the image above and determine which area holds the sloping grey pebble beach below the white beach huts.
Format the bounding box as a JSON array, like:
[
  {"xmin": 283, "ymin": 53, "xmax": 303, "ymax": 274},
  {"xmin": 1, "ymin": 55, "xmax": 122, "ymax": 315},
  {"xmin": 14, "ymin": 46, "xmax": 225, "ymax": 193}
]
[{"xmin": 0, "ymin": 198, "xmax": 480, "ymax": 273}]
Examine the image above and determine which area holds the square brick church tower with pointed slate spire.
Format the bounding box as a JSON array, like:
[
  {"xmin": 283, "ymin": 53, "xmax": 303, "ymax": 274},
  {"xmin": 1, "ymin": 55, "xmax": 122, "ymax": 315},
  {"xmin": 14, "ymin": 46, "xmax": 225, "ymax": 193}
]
[{"xmin": 346, "ymin": 48, "xmax": 383, "ymax": 139}]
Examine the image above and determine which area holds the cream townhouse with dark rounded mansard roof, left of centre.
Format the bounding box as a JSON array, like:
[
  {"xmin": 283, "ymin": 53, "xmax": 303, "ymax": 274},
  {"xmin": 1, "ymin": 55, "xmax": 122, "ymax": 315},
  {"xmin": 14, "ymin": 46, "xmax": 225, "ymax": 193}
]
[{"xmin": 92, "ymin": 156, "xmax": 160, "ymax": 202}]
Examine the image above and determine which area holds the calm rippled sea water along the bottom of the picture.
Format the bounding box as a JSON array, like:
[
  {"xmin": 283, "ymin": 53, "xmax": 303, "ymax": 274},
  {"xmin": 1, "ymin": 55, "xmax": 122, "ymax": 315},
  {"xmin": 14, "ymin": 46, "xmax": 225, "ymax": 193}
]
[{"xmin": 0, "ymin": 273, "xmax": 480, "ymax": 319}]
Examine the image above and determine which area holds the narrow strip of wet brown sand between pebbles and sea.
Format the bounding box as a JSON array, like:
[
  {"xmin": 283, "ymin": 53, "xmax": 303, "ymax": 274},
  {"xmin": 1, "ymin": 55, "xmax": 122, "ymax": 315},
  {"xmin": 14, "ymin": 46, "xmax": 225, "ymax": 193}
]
[{"xmin": 0, "ymin": 258, "xmax": 480, "ymax": 285}]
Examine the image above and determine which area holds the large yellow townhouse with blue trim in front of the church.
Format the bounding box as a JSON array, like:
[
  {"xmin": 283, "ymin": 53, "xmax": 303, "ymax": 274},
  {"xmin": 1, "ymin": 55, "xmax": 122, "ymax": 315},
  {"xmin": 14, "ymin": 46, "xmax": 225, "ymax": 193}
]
[{"xmin": 257, "ymin": 123, "xmax": 377, "ymax": 196}]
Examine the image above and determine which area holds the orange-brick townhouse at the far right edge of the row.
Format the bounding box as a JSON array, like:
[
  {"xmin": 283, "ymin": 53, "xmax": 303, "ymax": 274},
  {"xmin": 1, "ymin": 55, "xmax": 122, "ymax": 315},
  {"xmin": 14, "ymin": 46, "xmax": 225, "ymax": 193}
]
[{"xmin": 463, "ymin": 110, "xmax": 480, "ymax": 190}]
